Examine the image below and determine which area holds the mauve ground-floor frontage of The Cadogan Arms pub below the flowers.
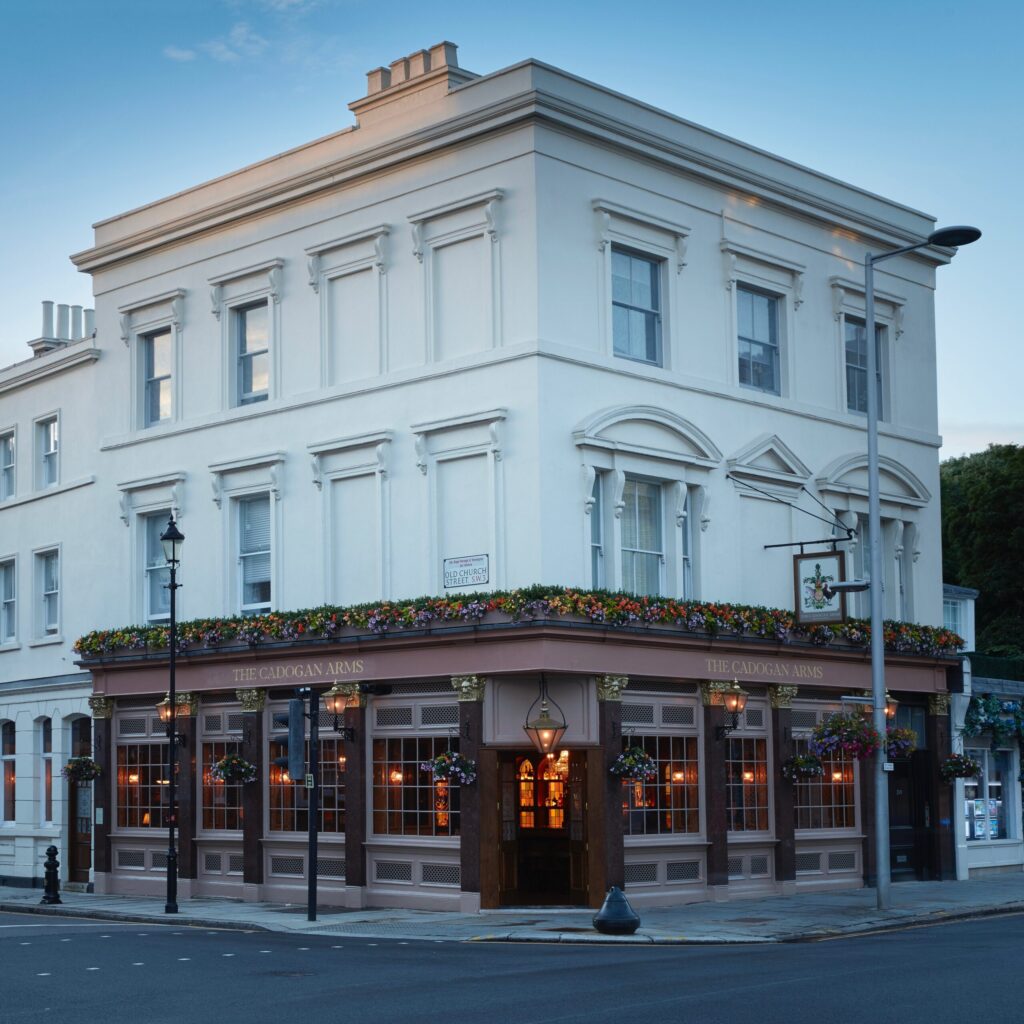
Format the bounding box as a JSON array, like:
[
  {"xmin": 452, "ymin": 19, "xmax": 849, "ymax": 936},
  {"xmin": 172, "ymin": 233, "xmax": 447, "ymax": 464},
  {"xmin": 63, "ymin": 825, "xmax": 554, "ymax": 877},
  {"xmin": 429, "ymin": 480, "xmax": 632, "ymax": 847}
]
[{"xmin": 79, "ymin": 612, "xmax": 956, "ymax": 911}]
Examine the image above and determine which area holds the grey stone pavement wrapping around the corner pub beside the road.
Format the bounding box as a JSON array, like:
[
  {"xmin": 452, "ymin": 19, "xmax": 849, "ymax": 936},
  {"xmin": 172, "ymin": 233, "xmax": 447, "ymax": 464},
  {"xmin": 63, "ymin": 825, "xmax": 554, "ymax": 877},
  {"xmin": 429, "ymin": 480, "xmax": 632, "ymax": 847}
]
[{"xmin": 0, "ymin": 871, "xmax": 1024, "ymax": 945}]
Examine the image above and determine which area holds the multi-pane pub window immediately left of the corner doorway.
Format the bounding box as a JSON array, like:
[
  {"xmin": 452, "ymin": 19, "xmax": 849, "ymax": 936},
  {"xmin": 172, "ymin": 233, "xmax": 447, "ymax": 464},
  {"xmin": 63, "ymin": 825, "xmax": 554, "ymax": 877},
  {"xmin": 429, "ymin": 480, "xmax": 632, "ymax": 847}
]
[{"xmin": 373, "ymin": 736, "xmax": 459, "ymax": 836}]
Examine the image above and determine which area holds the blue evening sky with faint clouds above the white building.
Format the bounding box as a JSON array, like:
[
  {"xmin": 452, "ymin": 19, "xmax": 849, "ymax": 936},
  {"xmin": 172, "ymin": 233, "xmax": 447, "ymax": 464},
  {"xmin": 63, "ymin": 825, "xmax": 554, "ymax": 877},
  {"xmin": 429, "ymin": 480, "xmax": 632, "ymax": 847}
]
[{"xmin": 0, "ymin": 0, "xmax": 1024, "ymax": 458}]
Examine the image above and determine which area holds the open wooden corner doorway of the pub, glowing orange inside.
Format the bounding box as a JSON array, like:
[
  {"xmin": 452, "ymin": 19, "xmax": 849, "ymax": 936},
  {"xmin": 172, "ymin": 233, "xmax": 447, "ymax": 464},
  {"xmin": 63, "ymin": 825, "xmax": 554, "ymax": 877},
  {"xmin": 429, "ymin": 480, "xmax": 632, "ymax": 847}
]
[{"xmin": 498, "ymin": 751, "xmax": 589, "ymax": 906}]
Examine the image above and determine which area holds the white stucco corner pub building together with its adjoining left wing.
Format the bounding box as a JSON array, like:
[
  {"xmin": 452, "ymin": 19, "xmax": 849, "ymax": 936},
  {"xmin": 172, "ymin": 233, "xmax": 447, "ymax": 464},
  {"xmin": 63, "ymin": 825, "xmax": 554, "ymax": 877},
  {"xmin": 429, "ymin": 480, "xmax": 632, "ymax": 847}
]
[{"xmin": 0, "ymin": 43, "xmax": 970, "ymax": 907}]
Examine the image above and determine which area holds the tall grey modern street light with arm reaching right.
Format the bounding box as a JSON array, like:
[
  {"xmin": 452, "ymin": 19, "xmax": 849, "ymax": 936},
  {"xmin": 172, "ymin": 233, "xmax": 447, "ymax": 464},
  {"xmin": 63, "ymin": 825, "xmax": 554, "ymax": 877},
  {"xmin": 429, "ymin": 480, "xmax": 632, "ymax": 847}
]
[{"xmin": 864, "ymin": 226, "xmax": 981, "ymax": 910}]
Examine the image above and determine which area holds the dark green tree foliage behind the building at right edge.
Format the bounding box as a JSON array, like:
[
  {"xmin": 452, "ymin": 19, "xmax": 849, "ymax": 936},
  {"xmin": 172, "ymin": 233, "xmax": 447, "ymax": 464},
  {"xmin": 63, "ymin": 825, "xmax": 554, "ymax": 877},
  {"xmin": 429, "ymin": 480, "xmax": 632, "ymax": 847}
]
[{"xmin": 939, "ymin": 444, "xmax": 1024, "ymax": 656}]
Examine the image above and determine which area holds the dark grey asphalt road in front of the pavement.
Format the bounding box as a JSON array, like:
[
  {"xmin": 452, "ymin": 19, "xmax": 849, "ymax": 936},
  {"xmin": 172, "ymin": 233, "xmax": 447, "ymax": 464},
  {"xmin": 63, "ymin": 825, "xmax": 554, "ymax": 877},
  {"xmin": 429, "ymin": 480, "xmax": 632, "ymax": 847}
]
[{"xmin": 0, "ymin": 914, "xmax": 1024, "ymax": 1024}]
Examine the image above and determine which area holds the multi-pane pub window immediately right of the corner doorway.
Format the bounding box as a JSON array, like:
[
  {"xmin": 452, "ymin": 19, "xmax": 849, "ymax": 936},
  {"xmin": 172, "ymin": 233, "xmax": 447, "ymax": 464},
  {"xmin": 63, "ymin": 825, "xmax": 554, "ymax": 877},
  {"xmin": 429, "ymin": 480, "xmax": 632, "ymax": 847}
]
[{"xmin": 623, "ymin": 736, "xmax": 700, "ymax": 836}]
